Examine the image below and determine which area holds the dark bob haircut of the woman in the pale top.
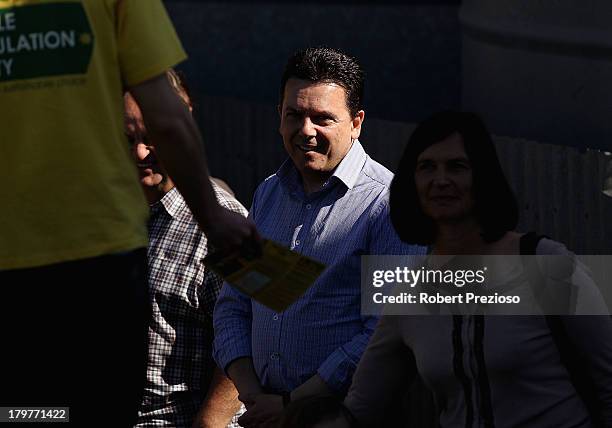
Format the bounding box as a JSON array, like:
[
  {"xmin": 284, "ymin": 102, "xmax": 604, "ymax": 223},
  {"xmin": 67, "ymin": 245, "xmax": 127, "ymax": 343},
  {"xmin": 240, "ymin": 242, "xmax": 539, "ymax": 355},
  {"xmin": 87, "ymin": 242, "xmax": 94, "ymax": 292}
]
[{"xmin": 390, "ymin": 111, "xmax": 518, "ymax": 245}]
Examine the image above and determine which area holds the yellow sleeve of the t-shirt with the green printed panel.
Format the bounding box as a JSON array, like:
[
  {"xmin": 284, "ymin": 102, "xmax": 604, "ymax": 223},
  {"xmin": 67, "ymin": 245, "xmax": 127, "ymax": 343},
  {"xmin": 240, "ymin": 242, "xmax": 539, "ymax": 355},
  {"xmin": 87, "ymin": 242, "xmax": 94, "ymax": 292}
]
[{"xmin": 116, "ymin": 0, "xmax": 187, "ymax": 87}]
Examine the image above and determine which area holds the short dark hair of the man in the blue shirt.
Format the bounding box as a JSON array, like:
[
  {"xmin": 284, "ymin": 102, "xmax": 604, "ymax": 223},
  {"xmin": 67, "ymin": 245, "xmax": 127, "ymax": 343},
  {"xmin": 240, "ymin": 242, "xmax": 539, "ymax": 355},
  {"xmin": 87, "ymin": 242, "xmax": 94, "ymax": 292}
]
[{"xmin": 279, "ymin": 47, "xmax": 364, "ymax": 117}]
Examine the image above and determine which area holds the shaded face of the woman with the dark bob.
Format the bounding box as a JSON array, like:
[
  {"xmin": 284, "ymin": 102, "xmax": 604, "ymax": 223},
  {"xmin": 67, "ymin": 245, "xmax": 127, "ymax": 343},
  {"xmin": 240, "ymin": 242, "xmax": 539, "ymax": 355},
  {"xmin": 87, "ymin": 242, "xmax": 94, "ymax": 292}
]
[{"xmin": 414, "ymin": 133, "xmax": 474, "ymax": 222}]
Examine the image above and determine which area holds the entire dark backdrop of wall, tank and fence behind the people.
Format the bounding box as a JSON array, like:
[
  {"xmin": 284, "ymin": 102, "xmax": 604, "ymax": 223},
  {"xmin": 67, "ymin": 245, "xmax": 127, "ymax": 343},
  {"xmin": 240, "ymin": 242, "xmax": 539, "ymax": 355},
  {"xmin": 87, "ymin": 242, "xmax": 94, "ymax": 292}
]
[{"xmin": 160, "ymin": 0, "xmax": 612, "ymax": 253}]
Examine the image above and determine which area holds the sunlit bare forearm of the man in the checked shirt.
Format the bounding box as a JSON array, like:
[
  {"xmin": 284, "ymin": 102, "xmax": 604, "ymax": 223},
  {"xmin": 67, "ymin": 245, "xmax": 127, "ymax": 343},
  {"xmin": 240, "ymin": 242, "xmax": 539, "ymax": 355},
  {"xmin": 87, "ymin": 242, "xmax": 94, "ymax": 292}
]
[{"xmin": 193, "ymin": 368, "xmax": 241, "ymax": 428}]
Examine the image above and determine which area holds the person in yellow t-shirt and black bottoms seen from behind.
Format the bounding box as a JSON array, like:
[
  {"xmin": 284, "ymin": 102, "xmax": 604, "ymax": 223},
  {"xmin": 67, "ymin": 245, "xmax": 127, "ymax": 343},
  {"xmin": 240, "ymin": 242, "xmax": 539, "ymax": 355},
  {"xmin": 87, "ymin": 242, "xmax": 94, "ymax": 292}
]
[{"xmin": 0, "ymin": 0, "xmax": 258, "ymax": 427}]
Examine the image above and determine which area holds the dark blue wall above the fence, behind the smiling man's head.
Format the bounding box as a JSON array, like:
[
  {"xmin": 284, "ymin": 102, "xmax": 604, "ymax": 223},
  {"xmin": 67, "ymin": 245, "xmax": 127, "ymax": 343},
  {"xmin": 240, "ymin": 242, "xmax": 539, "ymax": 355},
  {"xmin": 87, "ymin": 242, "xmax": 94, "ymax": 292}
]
[{"xmin": 166, "ymin": 0, "xmax": 461, "ymax": 122}]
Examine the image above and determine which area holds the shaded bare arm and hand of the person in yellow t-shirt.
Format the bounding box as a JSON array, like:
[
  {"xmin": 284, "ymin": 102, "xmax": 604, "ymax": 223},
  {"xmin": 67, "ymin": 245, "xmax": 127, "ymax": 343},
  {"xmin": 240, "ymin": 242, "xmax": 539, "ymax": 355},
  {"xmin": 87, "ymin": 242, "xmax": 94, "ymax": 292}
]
[{"xmin": 129, "ymin": 74, "xmax": 259, "ymax": 250}]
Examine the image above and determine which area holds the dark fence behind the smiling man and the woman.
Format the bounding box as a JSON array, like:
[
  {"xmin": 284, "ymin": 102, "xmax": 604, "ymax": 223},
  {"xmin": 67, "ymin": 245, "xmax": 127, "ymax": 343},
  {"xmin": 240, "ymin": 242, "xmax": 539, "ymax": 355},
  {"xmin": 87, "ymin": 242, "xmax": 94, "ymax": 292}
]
[{"xmin": 196, "ymin": 97, "xmax": 612, "ymax": 254}]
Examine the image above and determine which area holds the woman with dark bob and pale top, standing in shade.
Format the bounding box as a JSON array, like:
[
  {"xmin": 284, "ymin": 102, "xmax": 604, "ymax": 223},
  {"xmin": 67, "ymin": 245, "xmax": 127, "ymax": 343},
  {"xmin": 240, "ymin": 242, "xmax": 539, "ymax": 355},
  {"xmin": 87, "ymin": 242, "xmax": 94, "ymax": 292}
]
[{"xmin": 345, "ymin": 111, "xmax": 612, "ymax": 428}]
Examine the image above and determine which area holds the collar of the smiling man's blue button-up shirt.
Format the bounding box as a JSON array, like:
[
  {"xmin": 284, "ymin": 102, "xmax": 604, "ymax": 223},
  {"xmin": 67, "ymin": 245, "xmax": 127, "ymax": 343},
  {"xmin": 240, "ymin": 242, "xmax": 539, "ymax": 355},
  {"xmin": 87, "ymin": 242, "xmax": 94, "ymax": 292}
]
[{"xmin": 276, "ymin": 140, "xmax": 368, "ymax": 189}]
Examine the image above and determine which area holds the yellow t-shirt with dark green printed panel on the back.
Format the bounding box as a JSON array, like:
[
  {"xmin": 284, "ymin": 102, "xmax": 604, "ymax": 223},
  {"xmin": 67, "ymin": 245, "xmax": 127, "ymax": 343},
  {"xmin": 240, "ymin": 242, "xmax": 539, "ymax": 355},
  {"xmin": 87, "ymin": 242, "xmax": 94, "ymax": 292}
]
[{"xmin": 0, "ymin": 0, "xmax": 186, "ymax": 270}]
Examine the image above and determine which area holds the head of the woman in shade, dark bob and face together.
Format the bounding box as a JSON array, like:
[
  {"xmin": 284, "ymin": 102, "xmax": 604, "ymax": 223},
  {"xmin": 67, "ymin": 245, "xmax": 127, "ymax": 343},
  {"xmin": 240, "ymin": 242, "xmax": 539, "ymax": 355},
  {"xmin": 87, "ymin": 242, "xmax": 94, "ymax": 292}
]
[{"xmin": 390, "ymin": 111, "xmax": 518, "ymax": 247}]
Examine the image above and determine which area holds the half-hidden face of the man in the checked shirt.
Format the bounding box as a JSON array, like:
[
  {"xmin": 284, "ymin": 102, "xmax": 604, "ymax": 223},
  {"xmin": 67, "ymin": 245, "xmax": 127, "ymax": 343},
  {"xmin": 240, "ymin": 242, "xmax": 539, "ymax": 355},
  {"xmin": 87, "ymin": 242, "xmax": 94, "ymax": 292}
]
[{"xmin": 124, "ymin": 94, "xmax": 174, "ymax": 202}]
